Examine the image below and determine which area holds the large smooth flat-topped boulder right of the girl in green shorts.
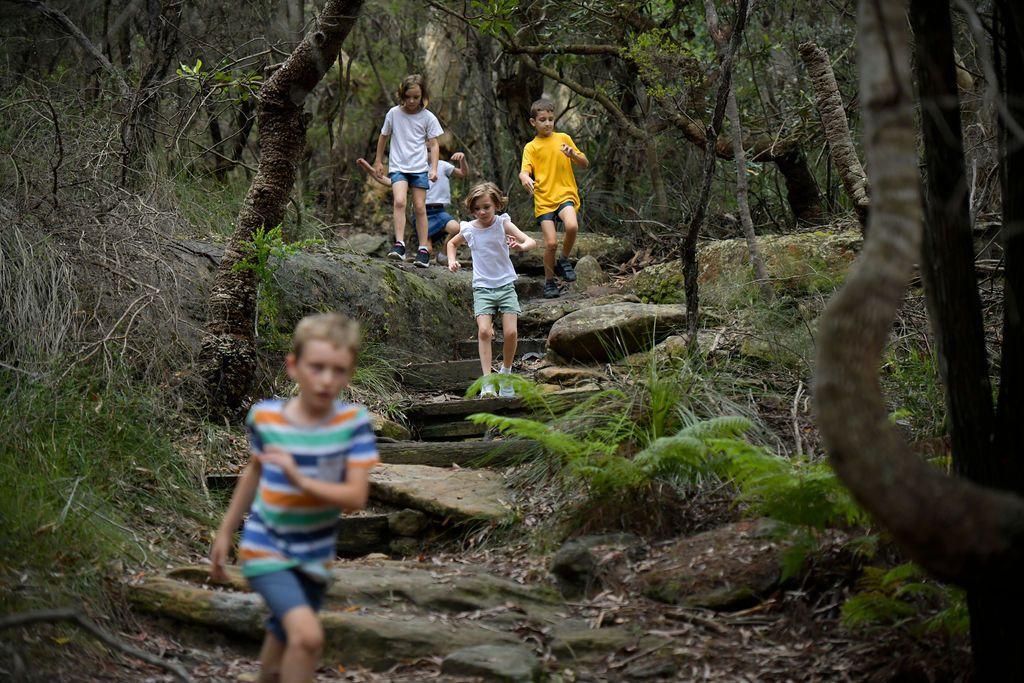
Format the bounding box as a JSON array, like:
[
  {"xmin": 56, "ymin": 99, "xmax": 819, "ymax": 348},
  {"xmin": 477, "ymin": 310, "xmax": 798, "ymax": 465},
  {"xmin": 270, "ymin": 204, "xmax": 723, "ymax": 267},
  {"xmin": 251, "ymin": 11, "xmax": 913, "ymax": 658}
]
[{"xmin": 548, "ymin": 303, "xmax": 686, "ymax": 361}]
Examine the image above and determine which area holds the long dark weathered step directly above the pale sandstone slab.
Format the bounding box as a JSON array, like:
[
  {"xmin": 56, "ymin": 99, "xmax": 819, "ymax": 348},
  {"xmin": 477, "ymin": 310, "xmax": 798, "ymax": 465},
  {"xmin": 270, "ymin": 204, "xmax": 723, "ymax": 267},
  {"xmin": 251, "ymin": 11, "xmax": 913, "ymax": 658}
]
[{"xmin": 206, "ymin": 444, "xmax": 537, "ymax": 489}]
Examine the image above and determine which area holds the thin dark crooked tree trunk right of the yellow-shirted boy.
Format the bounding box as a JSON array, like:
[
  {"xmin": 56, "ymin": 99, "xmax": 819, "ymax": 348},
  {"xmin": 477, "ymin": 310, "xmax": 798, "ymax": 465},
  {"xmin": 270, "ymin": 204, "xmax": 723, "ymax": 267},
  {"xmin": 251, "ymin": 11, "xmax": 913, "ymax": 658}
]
[{"xmin": 682, "ymin": 0, "xmax": 749, "ymax": 342}]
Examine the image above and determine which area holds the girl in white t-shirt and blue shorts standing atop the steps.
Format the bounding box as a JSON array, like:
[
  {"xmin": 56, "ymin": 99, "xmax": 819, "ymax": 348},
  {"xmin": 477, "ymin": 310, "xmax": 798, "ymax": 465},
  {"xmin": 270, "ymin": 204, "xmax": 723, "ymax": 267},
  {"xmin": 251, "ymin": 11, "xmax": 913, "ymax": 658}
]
[{"xmin": 374, "ymin": 74, "xmax": 444, "ymax": 268}]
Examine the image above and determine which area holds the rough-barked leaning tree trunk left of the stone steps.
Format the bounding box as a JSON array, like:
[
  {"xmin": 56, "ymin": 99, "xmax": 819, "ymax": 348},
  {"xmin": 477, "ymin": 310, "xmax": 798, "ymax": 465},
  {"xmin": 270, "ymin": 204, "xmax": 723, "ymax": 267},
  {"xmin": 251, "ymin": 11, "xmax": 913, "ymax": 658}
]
[{"xmin": 199, "ymin": 0, "xmax": 362, "ymax": 415}]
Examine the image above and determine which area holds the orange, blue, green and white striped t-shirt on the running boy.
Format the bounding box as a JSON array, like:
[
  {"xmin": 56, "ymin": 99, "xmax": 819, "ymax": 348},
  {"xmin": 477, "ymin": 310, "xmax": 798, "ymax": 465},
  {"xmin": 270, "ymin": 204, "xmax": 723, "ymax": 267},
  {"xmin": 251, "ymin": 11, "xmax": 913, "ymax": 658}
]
[{"xmin": 239, "ymin": 399, "xmax": 378, "ymax": 580}]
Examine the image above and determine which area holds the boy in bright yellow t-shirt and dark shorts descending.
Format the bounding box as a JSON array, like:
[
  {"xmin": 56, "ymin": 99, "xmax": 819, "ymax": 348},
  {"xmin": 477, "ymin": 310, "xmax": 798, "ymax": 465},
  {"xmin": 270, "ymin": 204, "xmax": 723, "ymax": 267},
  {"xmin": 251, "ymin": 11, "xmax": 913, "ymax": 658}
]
[{"xmin": 519, "ymin": 97, "xmax": 590, "ymax": 299}]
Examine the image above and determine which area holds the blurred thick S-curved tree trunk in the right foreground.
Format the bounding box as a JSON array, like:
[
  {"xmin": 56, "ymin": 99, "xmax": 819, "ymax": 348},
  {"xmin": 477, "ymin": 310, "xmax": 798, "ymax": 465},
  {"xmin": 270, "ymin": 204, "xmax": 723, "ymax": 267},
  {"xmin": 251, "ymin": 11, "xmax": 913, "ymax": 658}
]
[{"xmin": 814, "ymin": 0, "xmax": 1024, "ymax": 680}]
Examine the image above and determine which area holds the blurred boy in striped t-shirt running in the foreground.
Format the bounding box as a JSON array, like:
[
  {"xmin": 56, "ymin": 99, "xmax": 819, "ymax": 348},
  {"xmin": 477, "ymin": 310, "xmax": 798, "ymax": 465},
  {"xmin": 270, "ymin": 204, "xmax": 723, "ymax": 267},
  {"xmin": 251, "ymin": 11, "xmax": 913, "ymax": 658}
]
[{"xmin": 210, "ymin": 313, "xmax": 378, "ymax": 682}]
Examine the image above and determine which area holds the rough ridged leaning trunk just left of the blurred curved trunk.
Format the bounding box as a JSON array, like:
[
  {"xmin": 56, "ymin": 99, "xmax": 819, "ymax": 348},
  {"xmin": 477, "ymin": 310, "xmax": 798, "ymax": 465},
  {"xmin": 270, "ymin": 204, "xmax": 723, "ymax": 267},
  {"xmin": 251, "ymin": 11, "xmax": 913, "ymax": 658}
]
[{"xmin": 800, "ymin": 41, "xmax": 868, "ymax": 227}]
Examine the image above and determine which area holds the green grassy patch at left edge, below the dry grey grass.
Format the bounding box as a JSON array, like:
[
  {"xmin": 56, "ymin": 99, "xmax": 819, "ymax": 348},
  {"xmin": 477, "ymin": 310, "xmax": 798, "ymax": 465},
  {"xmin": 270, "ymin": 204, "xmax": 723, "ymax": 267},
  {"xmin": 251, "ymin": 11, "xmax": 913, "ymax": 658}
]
[{"xmin": 0, "ymin": 371, "xmax": 211, "ymax": 611}]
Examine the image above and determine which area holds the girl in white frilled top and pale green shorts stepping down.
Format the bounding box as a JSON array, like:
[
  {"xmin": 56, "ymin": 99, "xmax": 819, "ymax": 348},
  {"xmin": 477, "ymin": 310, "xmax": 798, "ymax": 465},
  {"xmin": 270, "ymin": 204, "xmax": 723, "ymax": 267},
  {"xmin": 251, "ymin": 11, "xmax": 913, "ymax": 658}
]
[{"xmin": 447, "ymin": 182, "xmax": 537, "ymax": 397}]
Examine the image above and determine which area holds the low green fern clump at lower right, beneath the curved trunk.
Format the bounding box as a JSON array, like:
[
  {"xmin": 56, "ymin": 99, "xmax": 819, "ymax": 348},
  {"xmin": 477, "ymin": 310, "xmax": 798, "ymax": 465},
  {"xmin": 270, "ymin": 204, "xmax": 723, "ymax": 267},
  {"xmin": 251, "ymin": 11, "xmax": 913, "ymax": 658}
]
[{"xmin": 842, "ymin": 562, "xmax": 970, "ymax": 636}]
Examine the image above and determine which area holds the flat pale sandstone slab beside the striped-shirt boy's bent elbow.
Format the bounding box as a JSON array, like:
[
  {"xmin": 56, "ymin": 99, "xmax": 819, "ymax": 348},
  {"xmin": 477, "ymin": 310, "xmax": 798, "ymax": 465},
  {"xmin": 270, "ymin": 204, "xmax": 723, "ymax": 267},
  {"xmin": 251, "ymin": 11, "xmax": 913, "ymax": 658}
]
[{"xmin": 370, "ymin": 464, "xmax": 512, "ymax": 522}]
